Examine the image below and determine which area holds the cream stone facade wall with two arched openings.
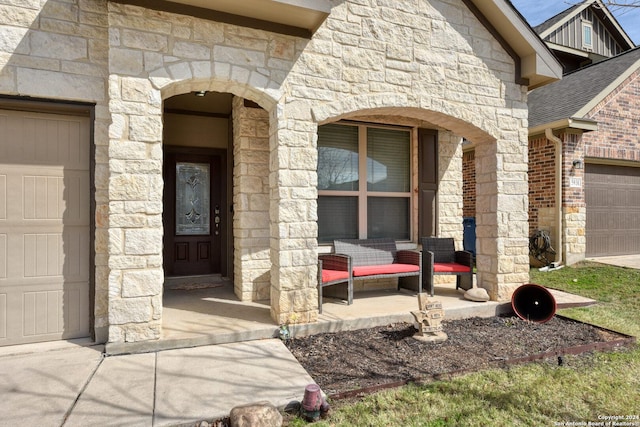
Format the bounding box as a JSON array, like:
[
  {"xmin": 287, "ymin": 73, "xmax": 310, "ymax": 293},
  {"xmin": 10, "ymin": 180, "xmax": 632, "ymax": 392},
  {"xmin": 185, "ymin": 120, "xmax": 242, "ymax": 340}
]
[{"xmin": 0, "ymin": 0, "xmax": 528, "ymax": 343}]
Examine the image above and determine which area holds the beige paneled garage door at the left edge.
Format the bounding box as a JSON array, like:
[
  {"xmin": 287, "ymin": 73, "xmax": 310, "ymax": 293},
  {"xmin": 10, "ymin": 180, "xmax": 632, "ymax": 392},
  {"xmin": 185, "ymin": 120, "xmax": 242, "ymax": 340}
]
[{"xmin": 0, "ymin": 110, "xmax": 90, "ymax": 346}]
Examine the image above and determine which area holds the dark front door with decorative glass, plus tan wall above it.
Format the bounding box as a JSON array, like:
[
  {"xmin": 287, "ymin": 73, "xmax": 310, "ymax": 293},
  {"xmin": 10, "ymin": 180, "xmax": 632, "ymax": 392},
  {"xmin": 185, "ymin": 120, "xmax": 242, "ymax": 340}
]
[{"xmin": 163, "ymin": 91, "xmax": 233, "ymax": 287}]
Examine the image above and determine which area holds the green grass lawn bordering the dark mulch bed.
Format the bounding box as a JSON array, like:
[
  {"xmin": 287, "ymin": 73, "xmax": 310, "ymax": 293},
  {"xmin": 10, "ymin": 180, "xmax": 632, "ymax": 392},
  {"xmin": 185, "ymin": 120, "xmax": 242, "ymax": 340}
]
[{"xmin": 289, "ymin": 263, "xmax": 640, "ymax": 427}]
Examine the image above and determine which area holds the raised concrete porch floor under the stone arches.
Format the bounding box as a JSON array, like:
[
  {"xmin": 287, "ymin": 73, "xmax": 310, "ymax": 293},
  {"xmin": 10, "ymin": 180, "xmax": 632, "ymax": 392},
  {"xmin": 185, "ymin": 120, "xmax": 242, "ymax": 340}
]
[{"xmin": 105, "ymin": 281, "xmax": 595, "ymax": 354}]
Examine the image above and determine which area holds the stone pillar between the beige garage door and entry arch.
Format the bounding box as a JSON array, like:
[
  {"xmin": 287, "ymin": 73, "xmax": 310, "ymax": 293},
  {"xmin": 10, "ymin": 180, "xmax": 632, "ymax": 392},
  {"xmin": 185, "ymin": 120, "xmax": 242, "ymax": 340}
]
[{"xmin": 108, "ymin": 76, "xmax": 164, "ymax": 342}]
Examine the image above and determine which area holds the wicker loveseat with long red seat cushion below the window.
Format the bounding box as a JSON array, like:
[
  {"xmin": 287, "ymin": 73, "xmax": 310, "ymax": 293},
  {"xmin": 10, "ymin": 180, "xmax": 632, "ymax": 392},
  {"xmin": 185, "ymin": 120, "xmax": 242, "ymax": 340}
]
[{"xmin": 318, "ymin": 239, "xmax": 422, "ymax": 313}]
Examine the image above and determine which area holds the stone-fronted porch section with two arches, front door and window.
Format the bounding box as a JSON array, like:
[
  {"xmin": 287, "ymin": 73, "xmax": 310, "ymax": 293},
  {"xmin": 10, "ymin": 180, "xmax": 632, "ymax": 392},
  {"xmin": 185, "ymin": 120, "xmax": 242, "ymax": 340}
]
[{"xmin": 95, "ymin": 2, "xmax": 560, "ymax": 353}]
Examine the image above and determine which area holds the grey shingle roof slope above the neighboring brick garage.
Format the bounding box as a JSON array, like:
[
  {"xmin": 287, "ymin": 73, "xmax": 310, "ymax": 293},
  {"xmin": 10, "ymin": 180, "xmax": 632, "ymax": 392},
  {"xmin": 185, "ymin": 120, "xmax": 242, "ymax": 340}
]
[{"xmin": 528, "ymin": 47, "xmax": 640, "ymax": 127}]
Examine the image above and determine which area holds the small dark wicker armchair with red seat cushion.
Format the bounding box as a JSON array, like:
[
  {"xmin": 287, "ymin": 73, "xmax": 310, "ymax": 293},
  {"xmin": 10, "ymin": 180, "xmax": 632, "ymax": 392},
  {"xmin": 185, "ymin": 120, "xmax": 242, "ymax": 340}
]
[{"xmin": 420, "ymin": 237, "xmax": 473, "ymax": 296}]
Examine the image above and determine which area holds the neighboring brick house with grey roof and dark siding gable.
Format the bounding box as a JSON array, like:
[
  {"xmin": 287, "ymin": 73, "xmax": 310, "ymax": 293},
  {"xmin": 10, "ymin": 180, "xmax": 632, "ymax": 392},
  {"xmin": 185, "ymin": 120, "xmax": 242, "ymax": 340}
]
[{"xmin": 464, "ymin": 0, "xmax": 640, "ymax": 265}]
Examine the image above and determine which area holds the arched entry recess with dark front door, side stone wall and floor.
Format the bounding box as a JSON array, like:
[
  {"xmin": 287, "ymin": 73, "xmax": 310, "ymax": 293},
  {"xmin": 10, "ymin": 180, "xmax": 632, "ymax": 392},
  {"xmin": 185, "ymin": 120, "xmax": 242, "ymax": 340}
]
[{"xmin": 162, "ymin": 91, "xmax": 282, "ymax": 344}]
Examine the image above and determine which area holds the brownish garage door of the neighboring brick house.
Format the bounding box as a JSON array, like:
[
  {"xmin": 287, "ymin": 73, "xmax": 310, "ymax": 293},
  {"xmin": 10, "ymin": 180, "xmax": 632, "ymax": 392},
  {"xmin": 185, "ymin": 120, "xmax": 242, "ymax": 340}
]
[{"xmin": 585, "ymin": 164, "xmax": 640, "ymax": 256}]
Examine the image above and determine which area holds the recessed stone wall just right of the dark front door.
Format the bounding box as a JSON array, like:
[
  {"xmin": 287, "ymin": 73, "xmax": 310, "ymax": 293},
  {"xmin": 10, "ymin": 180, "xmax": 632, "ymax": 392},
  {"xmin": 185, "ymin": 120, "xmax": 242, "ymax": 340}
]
[{"xmin": 232, "ymin": 97, "xmax": 271, "ymax": 301}]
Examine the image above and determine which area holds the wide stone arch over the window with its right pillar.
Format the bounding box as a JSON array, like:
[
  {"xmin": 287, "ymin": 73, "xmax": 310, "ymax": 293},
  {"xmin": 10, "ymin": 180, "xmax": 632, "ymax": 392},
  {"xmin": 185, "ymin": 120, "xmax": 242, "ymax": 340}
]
[{"xmin": 312, "ymin": 99, "xmax": 529, "ymax": 301}]
